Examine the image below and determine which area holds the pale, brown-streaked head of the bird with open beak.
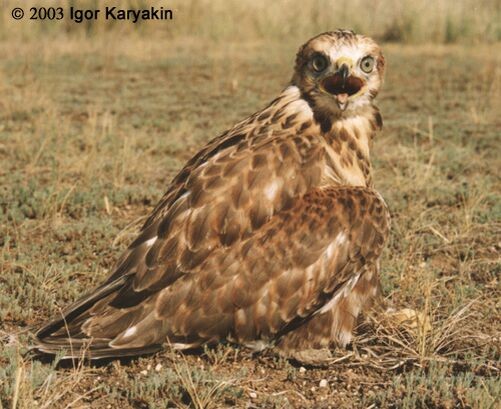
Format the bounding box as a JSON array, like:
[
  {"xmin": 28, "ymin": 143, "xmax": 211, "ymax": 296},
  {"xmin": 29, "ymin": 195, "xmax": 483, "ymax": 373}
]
[{"xmin": 292, "ymin": 30, "xmax": 384, "ymax": 115}]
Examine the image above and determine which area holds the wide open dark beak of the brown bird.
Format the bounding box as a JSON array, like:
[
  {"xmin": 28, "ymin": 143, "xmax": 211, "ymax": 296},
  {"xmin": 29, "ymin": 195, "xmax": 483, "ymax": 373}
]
[{"xmin": 321, "ymin": 58, "xmax": 364, "ymax": 111}]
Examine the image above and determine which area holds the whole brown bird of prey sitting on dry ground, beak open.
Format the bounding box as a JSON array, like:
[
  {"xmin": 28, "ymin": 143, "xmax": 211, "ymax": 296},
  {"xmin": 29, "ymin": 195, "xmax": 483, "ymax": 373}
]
[{"xmin": 35, "ymin": 30, "xmax": 389, "ymax": 359}]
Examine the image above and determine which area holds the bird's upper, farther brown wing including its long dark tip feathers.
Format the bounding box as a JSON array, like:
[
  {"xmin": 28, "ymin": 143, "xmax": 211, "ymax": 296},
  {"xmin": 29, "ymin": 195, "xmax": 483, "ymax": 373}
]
[{"xmin": 37, "ymin": 119, "xmax": 323, "ymax": 350}]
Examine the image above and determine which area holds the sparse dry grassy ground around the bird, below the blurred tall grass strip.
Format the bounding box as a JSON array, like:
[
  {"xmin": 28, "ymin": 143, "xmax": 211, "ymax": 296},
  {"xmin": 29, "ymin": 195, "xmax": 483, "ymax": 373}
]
[{"xmin": 0, "ymin": 6, "xmax": 501, "ymax": 408}]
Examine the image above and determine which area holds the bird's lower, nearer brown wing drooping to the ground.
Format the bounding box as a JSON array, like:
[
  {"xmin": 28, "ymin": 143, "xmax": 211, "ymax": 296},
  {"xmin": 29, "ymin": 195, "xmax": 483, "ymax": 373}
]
[{"xmin": 36, "ymin": 182, "xmax": 388, "ymax": 357}]
